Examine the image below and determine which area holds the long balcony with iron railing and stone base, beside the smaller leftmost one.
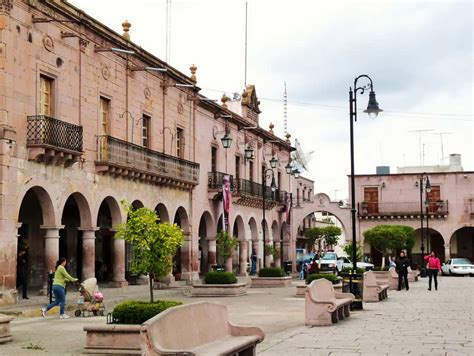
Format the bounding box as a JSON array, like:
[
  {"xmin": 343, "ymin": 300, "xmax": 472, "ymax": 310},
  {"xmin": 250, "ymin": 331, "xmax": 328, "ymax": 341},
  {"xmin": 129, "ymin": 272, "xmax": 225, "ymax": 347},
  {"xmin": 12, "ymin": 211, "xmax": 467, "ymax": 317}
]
[{"xmin": 95, "ymin": 135, "xmax": 199, "ymax": 189}]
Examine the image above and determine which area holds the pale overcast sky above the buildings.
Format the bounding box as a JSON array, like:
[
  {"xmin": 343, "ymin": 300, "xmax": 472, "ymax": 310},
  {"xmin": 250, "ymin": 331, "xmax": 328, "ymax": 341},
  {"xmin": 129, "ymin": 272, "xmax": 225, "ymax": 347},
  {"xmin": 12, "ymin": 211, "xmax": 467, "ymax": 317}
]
[{"xmin": 69, "ymin": 0, "xmax": 474, "ymax": 199}]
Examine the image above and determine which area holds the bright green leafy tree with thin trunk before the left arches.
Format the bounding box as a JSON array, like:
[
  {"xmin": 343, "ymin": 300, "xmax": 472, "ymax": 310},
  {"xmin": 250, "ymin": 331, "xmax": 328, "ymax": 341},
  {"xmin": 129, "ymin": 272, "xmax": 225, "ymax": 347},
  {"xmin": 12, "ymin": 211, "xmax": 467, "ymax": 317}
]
[{"xmin": 115, "ymin": 200, "xmax": 184, "ymax": 303}]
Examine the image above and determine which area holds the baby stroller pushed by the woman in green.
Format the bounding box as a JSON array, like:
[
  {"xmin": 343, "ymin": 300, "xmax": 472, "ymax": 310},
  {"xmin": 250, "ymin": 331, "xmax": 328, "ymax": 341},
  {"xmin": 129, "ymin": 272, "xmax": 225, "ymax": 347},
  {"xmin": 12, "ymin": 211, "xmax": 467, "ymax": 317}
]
[{"xmin": 74, "ymin": 278, "xmax": 105, "ymax": 317}]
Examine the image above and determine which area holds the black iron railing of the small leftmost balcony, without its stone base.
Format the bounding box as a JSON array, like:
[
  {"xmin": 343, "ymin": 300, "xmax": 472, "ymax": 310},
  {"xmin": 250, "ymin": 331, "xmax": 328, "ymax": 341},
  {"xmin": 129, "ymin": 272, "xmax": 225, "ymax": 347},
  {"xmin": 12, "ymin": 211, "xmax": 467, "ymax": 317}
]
[{"xmin": 26, "ymin": 115, "xmax": 82, "ymax": 152}]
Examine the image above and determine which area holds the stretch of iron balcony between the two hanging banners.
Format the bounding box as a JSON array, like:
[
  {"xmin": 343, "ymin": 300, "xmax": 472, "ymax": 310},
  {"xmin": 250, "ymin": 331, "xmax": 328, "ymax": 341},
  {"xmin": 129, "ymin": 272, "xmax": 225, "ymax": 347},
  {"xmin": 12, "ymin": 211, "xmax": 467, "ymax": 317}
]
[{"xmin": 233, "ymin": 179, "xmax": 286, "ymax": 209}]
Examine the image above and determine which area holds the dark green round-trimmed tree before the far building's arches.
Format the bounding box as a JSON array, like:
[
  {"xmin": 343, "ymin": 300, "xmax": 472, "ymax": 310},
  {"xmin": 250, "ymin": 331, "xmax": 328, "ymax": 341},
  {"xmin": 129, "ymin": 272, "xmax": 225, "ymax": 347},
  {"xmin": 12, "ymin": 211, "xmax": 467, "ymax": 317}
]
[{"xmin": 364, "ymin": 225, "xmax": 415, "ymax": 267}]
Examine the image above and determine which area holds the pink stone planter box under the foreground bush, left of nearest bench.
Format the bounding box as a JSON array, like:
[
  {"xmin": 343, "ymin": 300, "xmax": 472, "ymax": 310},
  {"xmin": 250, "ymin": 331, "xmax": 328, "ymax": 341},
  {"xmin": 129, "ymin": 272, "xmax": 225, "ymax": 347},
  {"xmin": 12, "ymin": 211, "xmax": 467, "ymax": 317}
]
[{"xmin": 84, "ymin": 324, "xmax": 141, "ymax": 355}]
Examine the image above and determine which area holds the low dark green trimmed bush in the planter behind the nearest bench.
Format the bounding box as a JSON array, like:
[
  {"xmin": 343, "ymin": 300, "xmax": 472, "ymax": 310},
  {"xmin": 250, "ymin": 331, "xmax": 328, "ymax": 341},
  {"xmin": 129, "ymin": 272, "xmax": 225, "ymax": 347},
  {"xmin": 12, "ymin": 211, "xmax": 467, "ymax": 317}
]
[{"xmin": 112, "ymin": 300, "xmax": 183, "ymax": 324}]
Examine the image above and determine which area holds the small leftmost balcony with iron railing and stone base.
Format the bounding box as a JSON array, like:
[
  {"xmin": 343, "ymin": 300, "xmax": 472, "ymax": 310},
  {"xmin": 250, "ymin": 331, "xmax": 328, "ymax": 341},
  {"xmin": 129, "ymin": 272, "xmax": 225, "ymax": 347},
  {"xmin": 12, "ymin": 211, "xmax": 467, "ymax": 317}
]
[{"xmin": 26, "ymin": 115, "xmax": 82, "ymax": 167}]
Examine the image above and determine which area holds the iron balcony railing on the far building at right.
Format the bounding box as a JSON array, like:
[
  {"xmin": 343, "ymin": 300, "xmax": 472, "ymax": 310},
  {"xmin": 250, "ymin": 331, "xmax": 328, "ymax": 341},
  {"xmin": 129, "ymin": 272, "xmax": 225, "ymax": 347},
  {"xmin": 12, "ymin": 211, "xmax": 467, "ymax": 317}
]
[{"xmin": 357, "ymin": 200, "xmax": 449, "ymax": 216}]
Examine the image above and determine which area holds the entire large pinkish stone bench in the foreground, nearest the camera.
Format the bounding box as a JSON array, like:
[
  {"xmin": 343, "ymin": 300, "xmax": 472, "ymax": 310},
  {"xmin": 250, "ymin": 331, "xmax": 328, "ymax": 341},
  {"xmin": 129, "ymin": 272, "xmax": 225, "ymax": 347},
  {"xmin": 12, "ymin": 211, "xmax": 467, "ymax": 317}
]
[{"xmin": 140, "ymin": 302, "xmax": 265, "ymax": 356}]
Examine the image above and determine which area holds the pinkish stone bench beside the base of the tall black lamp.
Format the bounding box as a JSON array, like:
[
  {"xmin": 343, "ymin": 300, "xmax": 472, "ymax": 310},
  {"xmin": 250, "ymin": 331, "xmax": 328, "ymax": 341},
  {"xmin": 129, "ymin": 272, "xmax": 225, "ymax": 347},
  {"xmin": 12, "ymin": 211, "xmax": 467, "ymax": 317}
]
[{"xmin": 305, "ymin": 278, "xmax": 355, "ymax": 326}]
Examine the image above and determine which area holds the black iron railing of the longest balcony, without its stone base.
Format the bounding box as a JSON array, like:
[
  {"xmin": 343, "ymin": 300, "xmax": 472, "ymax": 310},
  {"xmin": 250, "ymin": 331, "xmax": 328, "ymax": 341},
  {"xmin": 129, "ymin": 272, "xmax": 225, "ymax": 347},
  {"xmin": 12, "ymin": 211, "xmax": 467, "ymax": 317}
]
[{"xmin": 98, "ymin": 135, "xmax": 199, "ymax": 184}]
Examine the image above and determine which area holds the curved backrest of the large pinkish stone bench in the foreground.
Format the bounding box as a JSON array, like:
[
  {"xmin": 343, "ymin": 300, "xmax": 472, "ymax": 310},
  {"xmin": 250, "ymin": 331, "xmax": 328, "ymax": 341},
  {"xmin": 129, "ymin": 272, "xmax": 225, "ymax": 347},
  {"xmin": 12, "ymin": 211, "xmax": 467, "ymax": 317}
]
[{"xmin": 142, "ymin": 302, "xmax": 229, "ymax": 349}]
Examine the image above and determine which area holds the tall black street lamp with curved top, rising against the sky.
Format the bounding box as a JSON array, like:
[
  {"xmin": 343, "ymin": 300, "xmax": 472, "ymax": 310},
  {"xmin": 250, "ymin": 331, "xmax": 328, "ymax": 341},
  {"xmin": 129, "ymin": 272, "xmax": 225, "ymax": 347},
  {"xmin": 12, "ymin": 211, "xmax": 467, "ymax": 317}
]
[{"xmin": 349, "ymin": 74, "xmax": 383, "ymax": 293}]
